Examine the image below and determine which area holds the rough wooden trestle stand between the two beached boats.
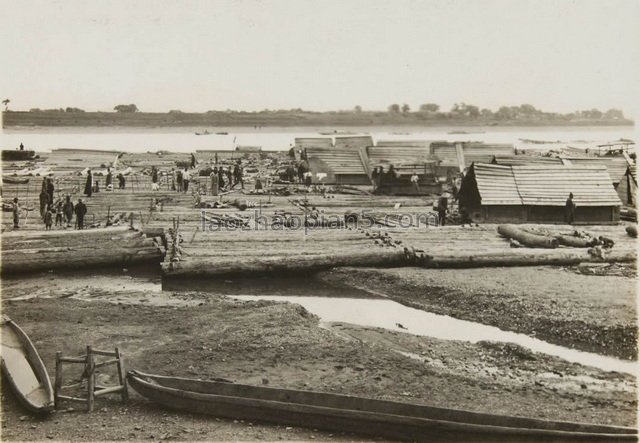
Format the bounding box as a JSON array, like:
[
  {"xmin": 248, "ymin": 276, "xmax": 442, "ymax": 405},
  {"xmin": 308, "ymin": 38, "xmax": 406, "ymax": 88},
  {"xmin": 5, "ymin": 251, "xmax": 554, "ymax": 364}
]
[{"xmin": 54, "ymin": 346, "xmax": 129, "ymax": 412}]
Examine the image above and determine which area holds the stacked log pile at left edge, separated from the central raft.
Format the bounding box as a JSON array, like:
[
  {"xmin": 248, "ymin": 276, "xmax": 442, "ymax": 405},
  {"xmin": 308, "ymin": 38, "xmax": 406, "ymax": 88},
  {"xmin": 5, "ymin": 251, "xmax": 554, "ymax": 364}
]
[{"xmin": 2, "ymin": 226, "xmax": 162, "ymax": 275}]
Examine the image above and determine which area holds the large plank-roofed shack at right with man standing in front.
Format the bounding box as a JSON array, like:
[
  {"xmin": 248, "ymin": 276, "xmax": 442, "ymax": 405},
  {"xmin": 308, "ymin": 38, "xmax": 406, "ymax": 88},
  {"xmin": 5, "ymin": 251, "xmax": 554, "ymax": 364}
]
[{"xmin": 458, "ymin": 163, "xmax": 620, "ymax": 224}]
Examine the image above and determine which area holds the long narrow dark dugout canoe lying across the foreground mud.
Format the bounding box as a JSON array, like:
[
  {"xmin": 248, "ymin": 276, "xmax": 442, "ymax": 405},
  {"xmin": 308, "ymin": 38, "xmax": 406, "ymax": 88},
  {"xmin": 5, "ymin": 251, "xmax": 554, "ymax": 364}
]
[{"xmin": 127, "ymin": 371, "xmax": 637, "ymax": 442}]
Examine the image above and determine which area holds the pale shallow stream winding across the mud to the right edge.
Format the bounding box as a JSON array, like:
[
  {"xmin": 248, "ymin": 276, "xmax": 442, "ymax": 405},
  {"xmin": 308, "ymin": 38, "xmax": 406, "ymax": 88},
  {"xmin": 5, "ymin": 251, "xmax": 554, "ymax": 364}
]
[{"xmin": 233, "ymin": 295, "xmax": 638, "ymax": 375}]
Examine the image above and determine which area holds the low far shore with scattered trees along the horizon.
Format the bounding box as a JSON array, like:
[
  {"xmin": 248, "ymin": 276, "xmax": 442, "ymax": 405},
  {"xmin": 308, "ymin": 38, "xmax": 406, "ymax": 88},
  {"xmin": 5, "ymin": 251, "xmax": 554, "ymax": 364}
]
[{"xmin": 2, "ymin": 103, "xmax": 633, "ymax": 128}]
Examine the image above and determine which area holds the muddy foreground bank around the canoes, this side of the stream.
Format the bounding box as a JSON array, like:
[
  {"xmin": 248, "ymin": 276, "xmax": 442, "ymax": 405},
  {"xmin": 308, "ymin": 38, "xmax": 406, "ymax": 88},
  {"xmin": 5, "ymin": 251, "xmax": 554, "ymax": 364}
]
[{"xmin": 2, "ymin": 270, "xmax": 637, "ymax": 441}]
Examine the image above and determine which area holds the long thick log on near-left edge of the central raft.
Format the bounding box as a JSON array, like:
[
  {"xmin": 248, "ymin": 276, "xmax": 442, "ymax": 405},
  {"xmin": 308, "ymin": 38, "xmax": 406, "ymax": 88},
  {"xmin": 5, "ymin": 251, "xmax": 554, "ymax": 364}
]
[{"xmin": 162, "ymin": 248, "xmax": 412, "ymax": 277}]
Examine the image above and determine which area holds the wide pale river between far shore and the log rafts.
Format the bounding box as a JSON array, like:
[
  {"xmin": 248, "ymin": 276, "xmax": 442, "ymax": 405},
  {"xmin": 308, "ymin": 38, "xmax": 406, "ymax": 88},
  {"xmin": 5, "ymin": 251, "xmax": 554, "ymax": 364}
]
[{"xmin": 0, "ymin": 126, "xmax": 634, "ymax": 152}]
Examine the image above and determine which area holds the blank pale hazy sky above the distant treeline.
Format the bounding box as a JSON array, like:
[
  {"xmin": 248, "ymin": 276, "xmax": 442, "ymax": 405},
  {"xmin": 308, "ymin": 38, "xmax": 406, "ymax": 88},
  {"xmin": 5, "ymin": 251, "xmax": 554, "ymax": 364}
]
[{"xmin": 0, "ymin": 0, "xmax": 640, "ymax": 114}]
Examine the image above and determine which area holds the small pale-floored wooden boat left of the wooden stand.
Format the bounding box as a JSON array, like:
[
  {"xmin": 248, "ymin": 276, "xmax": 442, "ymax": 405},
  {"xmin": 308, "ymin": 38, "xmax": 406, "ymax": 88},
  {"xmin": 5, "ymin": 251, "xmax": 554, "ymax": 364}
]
[{"xmin": 1, "ymin": 317, "xmax": 54, "ymax": 414}]
